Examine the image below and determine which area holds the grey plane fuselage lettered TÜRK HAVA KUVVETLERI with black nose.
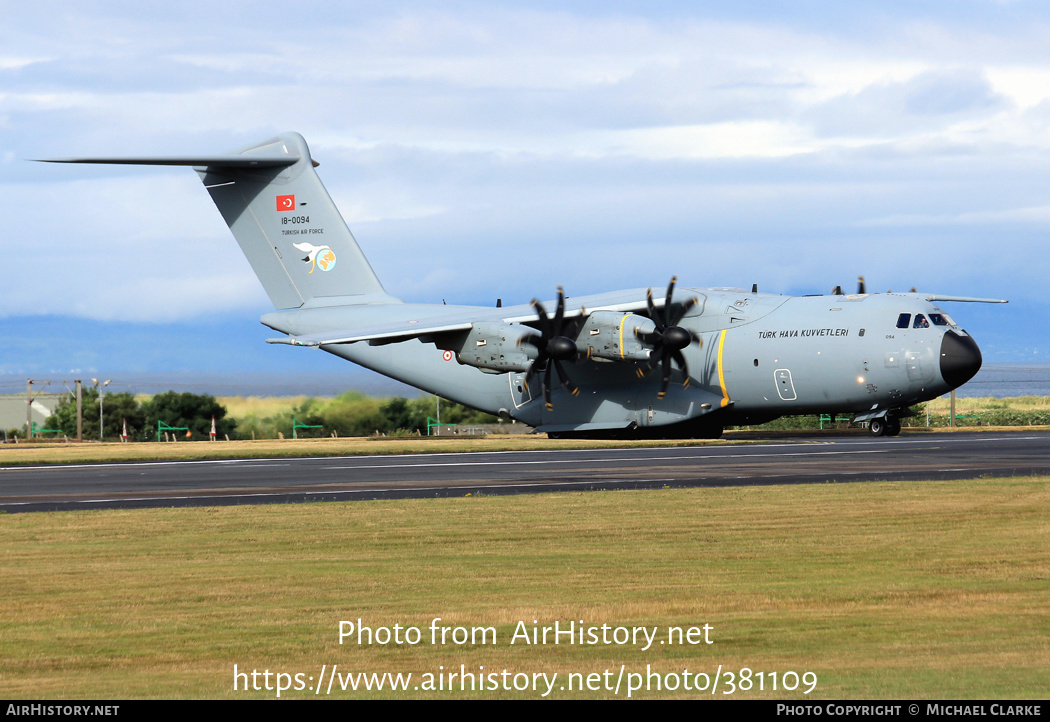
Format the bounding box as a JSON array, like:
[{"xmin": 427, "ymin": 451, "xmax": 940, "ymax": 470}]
[{"xmin": 264, "ymin": 289, "xmax": 981, "ymax": 427}]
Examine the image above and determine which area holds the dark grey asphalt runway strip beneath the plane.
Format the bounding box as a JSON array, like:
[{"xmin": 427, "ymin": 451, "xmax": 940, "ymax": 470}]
[{"xmin": 0, "ymin": 430, "xmax": 1050, "ymax": 512}]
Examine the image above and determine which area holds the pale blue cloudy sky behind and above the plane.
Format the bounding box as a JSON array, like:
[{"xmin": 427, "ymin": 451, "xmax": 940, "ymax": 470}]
[{"xmin": 0, "ymin": 0, "xmax": 1050, "ymax": 390}]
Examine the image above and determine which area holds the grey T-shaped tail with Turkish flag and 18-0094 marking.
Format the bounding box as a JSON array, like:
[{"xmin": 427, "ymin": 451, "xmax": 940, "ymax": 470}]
[{"xmin": 40, "ymin": 133, "xmax": 397, "ymax": 309}]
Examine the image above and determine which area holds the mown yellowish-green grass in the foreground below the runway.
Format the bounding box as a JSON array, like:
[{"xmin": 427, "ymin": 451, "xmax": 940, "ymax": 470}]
[{"xmin": 0, "ymin": 477, "xmax": 1050, "ymax": 699}]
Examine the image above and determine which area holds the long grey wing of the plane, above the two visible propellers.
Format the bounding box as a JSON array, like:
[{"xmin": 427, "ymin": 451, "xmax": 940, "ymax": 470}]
[{"xmin": 264, "ymin": 289, "xmax": 691, "ymax": 346}]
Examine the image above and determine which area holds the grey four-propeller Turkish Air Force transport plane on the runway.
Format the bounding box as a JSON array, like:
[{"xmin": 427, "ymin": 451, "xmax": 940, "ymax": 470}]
[{"xmin": 45, "ymin": 133, "xmax": 1005, "ymax": 438}]
